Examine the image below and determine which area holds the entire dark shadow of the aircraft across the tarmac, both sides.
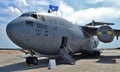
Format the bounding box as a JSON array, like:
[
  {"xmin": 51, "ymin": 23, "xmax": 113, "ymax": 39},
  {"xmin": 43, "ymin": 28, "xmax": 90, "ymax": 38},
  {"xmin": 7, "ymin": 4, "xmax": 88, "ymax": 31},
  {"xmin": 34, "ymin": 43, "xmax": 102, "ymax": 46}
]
[{"xmin": 0, "ymin": 55, "xmax": 120, "ymax": 72}]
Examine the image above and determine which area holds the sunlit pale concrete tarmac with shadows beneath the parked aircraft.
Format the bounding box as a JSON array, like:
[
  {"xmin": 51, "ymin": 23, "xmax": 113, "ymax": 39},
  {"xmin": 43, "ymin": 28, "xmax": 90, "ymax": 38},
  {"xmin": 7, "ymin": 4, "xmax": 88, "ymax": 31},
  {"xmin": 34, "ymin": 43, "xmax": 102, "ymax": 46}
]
[{"xmin": 0, "ymin": 50, "xmax": 120, "ymax": 72}]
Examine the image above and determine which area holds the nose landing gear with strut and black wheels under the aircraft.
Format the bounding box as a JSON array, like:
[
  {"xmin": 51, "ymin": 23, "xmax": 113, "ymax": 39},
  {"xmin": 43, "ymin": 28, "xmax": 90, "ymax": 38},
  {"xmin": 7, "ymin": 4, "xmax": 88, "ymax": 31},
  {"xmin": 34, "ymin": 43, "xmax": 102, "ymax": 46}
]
[{"xmin": 26, "ymin": 50, "xmax": 38, "ymax": 65}]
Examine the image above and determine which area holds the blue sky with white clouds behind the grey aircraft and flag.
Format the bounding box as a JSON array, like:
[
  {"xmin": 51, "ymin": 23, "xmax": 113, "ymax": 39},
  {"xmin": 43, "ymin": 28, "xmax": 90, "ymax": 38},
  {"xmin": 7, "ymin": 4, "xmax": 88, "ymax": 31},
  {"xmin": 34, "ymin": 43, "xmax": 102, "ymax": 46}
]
[{"xmin": 0, "ymin": 0, "xmax": 120, "ymax": 48}]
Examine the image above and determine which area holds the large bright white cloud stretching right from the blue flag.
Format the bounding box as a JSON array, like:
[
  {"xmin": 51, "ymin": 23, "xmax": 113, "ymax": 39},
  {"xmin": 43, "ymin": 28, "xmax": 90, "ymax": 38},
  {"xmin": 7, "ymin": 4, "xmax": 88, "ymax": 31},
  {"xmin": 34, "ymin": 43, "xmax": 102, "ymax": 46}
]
[{"xmin": 54, "ymin": 1, "xmax": 120, "ymax": 25}]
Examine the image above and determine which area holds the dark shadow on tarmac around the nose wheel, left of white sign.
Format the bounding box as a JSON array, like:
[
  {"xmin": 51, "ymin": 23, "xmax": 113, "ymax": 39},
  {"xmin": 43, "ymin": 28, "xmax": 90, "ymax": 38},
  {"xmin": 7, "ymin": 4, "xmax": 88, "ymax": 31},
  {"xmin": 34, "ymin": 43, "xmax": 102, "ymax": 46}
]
[{"xmin": 0, "ymin": 59, "xmax": 48, "ymax": 72}]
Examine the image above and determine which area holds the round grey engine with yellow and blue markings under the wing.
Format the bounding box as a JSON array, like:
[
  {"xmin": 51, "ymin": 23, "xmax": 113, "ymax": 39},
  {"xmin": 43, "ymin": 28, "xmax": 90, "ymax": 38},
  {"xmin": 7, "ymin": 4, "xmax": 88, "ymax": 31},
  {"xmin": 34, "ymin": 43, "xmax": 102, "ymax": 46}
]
[{"xmin": 97, "ymin": 26, "xmax": 114, "ymax": 43}]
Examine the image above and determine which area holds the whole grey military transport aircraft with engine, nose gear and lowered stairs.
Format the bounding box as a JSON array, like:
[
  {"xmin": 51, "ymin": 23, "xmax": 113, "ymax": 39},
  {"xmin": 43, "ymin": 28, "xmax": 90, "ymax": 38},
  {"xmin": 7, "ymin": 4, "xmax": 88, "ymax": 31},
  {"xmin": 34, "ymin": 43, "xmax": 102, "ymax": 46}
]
[{"xmin": 6, "ymin": 12, "xmax": 120, "ymax": 65}]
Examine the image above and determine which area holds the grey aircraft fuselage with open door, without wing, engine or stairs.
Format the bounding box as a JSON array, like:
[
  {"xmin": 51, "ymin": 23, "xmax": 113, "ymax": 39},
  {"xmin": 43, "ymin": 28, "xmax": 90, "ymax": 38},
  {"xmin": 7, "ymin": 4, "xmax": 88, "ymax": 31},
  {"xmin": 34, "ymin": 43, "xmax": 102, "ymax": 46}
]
[{"xmin": 6, "ymin": 12, "xmax": 98, "ymax": 55}]
